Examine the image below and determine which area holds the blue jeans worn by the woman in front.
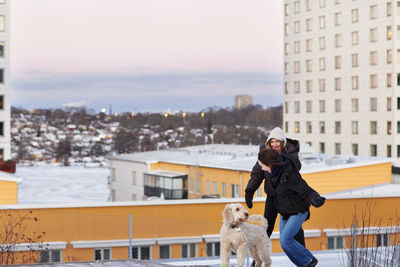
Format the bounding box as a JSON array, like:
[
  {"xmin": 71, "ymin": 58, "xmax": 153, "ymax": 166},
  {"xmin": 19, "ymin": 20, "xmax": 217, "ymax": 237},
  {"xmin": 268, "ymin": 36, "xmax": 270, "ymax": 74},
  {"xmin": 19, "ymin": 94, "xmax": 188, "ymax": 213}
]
[{"xmin": 279, "ymin": 211, "xmax": 313, "ymax": 267}]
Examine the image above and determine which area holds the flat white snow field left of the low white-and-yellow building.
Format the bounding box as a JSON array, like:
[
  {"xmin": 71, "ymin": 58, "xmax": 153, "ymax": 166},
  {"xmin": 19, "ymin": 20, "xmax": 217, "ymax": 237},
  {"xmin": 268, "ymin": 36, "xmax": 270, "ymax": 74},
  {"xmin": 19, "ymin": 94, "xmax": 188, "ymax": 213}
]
[{"xmin": 15, "ymin": 166, "xmax": 110, "ymax": 204}]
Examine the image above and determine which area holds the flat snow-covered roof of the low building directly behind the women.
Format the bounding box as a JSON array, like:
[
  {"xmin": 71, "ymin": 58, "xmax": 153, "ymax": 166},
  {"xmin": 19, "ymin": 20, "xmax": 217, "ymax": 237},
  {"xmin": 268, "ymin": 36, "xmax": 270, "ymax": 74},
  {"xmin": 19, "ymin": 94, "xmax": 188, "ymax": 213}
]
[{"xmin": 109, "ymin": 144, "xmax": 392, "ymax": 174}]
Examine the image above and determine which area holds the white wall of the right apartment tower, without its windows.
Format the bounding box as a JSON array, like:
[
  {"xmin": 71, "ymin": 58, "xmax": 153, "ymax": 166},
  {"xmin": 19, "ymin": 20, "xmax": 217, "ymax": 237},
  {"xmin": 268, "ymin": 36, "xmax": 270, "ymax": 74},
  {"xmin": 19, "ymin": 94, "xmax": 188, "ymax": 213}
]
[{"xmin": 283, "ymin": 0, "xmax": 400, "ymax": 163}]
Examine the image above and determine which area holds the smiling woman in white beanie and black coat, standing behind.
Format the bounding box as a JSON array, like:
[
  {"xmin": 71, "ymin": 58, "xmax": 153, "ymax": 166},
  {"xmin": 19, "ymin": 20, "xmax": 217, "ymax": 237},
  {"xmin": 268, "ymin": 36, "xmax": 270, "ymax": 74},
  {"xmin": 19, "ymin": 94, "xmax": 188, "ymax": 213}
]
[{"xmin": 245, "ymin": 127, "xmax": 306, "ymax": 247}]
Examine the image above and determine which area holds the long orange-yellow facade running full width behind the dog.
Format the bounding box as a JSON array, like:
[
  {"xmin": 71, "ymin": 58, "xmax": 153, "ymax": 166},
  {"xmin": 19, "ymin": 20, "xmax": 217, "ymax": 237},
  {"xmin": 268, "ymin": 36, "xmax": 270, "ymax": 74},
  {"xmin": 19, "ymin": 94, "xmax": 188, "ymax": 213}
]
[{"xmin": 0, "ymin": 189, "xmax": 400, "ymax": 262}]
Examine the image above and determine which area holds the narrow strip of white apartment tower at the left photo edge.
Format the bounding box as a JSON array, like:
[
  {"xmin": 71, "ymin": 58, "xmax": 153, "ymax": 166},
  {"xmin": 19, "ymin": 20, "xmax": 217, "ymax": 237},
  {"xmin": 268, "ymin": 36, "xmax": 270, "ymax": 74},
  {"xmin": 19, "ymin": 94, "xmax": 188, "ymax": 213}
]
[{"xmin": 0, "ymin": 0, "xmax": 11, "ymax": 160}]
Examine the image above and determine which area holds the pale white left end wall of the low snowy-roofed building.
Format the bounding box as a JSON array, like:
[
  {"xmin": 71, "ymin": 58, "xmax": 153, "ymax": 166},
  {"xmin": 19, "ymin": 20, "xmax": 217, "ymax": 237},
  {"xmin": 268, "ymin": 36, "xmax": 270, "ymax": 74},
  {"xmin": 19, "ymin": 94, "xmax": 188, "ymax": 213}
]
[{"xmin": 109, "ymin": 159, "xmax": 148, "ymax": 201}]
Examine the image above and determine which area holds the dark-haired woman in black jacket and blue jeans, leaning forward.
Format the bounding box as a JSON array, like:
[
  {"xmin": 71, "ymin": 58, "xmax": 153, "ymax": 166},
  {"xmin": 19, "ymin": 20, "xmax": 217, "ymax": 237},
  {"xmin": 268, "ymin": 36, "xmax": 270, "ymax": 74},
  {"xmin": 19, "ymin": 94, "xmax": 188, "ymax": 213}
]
[{"xmin": 258, "ymin": 148, "xmax": 325, "ymax": 267}]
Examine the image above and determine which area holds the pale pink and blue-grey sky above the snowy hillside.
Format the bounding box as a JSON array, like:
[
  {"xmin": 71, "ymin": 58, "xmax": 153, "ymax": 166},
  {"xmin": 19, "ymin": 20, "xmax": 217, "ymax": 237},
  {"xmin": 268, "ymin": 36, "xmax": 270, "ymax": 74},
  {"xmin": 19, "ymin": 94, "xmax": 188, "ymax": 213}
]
[{"xmin": 10, "ymin": 0, "xmax": 283, "ymax": 112}]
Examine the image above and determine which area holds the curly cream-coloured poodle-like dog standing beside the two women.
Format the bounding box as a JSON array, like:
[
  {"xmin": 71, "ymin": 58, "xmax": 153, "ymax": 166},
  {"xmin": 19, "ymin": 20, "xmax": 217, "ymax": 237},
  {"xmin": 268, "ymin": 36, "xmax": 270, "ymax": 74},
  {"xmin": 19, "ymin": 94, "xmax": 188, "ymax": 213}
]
[{"xmin": 220, "ymin": 204, "xmax": 271, "ymax": 267}]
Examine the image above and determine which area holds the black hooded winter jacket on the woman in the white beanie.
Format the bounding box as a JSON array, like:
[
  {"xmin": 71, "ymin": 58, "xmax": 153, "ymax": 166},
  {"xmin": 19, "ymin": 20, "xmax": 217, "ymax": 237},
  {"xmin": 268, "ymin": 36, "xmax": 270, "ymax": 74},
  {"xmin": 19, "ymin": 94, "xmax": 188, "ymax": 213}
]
[{"xmin": 245, "ymin": 138, "xmax": 301, "ymax": 197}]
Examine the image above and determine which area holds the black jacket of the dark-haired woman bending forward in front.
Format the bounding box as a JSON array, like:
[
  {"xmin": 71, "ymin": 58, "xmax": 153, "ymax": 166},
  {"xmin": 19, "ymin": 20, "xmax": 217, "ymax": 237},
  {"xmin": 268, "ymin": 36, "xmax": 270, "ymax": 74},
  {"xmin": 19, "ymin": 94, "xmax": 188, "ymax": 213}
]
[{"xmin": 271, "ymin": 155, "xmax": 319, "ymax": 219}]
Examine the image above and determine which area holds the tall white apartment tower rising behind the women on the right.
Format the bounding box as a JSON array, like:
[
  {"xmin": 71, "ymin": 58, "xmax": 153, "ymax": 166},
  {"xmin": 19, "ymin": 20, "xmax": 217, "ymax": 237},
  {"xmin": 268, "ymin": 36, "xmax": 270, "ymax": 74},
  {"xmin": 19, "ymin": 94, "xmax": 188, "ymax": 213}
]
[{"xmin": 283, "ymin": 0, "xmax": 400, "ymax": 166}]
